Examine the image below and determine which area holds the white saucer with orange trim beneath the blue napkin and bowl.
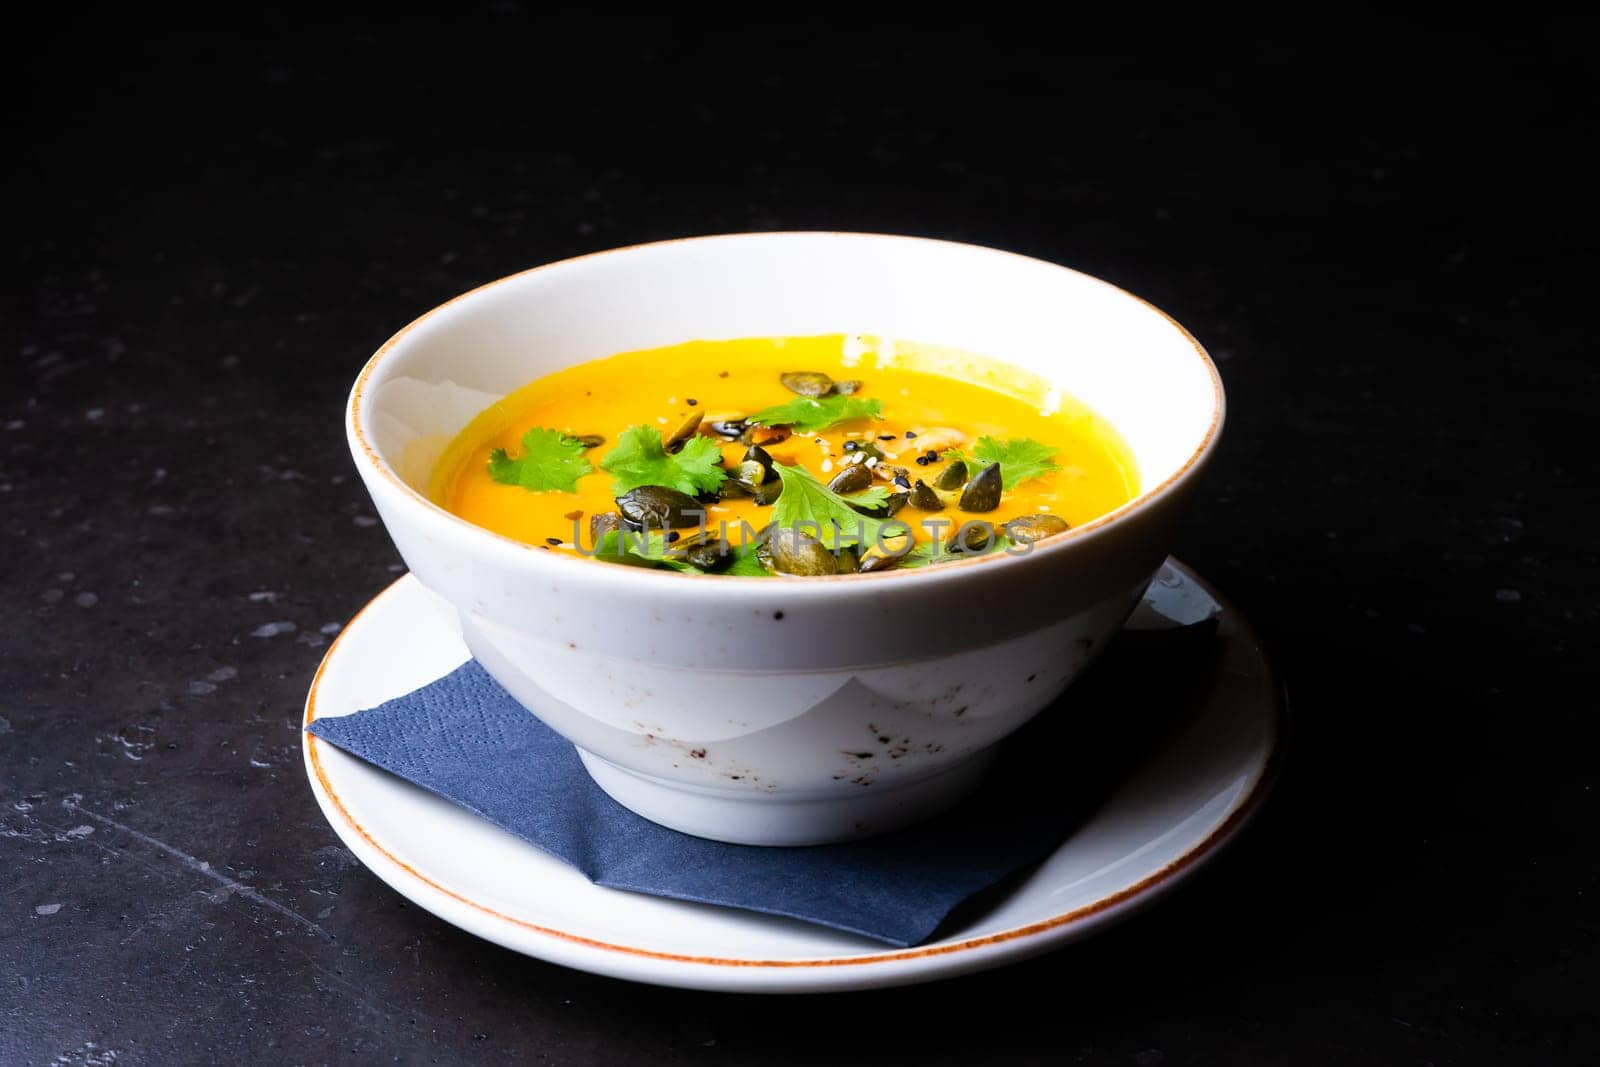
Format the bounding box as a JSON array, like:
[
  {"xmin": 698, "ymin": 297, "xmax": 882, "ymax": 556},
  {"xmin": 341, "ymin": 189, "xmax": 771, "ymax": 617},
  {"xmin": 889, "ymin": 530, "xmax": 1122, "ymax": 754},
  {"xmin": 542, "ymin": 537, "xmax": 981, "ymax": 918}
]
[{"xmin": 302, "ymin": 563, "xmax": 1283, "ymax": 992}]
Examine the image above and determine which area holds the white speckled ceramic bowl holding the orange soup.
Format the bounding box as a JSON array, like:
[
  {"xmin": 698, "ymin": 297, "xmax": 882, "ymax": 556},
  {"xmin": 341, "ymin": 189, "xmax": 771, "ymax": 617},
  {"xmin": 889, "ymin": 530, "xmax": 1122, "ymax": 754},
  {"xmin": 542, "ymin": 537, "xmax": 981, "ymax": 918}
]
[{"xmin": 347, "ymin": 234, "xmax": 1222, "ymax": 845}]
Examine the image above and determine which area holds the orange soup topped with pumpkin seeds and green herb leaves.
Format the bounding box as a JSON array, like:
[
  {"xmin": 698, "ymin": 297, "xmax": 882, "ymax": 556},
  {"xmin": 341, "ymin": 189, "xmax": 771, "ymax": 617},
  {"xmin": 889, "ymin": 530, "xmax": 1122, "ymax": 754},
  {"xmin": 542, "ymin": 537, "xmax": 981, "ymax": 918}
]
[{"xmin": 430, "ymin": 334, "xmax": 1139, "ymax": 576}]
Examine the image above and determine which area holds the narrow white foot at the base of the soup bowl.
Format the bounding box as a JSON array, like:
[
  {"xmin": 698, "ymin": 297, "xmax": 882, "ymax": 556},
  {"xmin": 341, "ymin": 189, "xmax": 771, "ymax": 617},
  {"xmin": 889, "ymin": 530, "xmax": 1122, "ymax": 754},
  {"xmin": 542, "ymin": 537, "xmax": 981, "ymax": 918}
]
[{"xmin": 578, "ymin": 745, "xmax": 998, "ymax": 845}]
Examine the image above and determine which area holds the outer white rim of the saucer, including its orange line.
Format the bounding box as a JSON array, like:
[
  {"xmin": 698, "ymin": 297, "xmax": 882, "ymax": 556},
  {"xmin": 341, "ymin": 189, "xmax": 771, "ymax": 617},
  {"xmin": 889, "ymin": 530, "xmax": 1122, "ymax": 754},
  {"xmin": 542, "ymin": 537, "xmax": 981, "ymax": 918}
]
[{"xmin": 301, "ymin": 557, "xmax": 1288, "ymax": 992}]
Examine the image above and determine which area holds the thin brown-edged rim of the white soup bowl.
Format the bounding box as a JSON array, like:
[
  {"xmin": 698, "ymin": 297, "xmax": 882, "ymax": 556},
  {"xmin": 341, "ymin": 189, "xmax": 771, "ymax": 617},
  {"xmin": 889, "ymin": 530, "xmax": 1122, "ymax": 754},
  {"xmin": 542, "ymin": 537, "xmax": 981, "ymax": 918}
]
[{"xmin": 344, "ymin": 230, "xmax": 1227, "ymax": 597}]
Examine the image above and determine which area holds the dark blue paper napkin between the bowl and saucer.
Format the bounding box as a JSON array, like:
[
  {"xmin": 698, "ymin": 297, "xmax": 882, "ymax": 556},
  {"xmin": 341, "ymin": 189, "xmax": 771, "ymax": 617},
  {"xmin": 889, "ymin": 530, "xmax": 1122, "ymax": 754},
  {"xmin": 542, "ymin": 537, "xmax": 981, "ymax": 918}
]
[{"xmin": 307, "ymin": 591, "xmax": 1214, "ymax": 947}]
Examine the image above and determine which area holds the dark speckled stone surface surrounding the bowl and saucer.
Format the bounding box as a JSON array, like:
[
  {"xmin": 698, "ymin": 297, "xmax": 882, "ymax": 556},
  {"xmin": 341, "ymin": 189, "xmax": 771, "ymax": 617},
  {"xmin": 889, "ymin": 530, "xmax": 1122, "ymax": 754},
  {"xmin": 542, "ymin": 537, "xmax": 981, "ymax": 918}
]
[{"xmin": 0, "ymin": 16, "xmax": 1600, "ymax": 1067}]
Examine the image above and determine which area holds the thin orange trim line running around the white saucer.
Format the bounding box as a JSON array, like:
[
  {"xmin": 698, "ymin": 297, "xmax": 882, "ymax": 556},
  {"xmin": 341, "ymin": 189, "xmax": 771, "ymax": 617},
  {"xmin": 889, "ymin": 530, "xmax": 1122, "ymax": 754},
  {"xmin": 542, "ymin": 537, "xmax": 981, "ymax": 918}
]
[{"xmin": 304, "ymin": 568, "xmax": 1283, "ymax": 968}]
